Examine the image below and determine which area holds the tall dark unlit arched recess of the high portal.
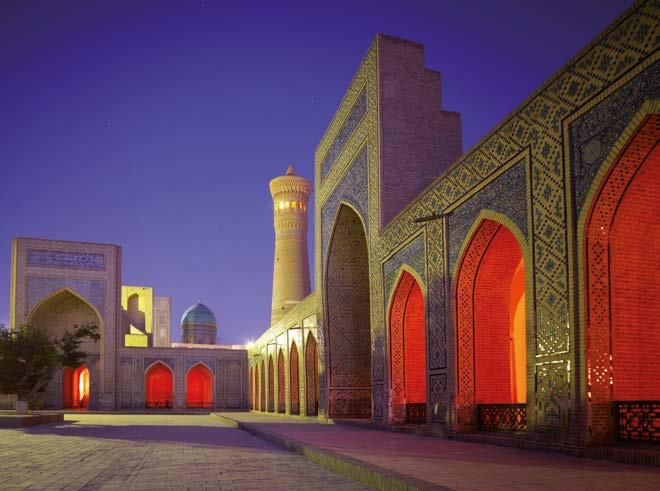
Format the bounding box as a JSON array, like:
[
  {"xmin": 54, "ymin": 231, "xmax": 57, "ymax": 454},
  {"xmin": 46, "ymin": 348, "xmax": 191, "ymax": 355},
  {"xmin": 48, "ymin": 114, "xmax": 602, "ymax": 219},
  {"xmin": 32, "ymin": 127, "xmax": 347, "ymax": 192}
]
[{"xmin": 325, "ymin": 205, "xmax": 371, "ymax": 418}]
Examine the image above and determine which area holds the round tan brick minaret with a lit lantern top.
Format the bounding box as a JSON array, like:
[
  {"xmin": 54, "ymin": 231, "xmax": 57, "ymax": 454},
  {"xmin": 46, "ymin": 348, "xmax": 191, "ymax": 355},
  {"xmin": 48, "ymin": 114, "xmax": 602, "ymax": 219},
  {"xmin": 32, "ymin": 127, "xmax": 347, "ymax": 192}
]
[{"xmin": 270, "ymin": 165, "xmax": 312, "ymax": 325}]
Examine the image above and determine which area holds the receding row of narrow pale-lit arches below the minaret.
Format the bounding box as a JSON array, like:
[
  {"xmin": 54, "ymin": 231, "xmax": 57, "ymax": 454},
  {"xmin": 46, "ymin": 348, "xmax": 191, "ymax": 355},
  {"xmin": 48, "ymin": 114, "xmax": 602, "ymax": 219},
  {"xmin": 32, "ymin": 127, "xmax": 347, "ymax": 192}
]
[{"xmin": 249, "ymin": 332, "xmax": 319, "ymax": 416}]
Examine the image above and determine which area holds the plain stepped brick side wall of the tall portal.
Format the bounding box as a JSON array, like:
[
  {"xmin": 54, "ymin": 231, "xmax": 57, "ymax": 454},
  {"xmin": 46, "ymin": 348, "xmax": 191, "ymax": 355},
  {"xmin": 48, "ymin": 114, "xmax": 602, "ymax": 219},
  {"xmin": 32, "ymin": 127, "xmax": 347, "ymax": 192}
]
[{"xmin": 378, "ymin": 34, "xmax": 462, "ymax": 225}]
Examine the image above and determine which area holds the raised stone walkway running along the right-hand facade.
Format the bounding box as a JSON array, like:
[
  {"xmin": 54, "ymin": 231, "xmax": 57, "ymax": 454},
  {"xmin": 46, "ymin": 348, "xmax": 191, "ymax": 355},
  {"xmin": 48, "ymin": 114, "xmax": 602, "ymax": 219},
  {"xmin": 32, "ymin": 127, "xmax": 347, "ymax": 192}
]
[{"xmin": 221, "ymin": 413, "xmax": 660, "ymax": 491}]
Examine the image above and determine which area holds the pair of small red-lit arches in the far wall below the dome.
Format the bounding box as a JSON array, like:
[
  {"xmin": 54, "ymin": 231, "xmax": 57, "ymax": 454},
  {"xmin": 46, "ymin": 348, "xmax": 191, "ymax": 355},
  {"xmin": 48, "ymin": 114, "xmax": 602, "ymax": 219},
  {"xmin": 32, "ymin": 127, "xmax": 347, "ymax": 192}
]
[{"xmin": 145, "ymin": 362, "xmax": 213, "ymax": 409}]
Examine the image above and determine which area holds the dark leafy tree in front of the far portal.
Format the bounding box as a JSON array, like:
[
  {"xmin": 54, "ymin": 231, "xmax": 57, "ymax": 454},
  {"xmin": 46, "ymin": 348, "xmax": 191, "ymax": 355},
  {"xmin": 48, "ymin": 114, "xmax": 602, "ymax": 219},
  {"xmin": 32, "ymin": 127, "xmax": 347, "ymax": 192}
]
[{"xmin": 0, "ymin": 324, "xmax": 101, "ymax": 408}]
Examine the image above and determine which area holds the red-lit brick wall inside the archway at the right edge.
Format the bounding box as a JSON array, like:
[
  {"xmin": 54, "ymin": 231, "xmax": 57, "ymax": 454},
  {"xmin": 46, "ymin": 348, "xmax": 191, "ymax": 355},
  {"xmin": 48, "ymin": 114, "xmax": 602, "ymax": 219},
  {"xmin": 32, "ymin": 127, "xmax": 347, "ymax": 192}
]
[{"xmin": 610, "ymin": 144, "xmax": 660, "ymax": 400}]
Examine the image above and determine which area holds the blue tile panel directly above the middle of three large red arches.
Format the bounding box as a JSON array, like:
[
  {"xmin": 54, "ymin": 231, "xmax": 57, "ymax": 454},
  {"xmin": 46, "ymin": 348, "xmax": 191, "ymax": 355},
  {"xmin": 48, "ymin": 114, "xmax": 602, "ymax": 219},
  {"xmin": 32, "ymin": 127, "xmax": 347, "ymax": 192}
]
[{"xmin": 447, "ymin": 159, "xmax": 529, "ymax": 271}]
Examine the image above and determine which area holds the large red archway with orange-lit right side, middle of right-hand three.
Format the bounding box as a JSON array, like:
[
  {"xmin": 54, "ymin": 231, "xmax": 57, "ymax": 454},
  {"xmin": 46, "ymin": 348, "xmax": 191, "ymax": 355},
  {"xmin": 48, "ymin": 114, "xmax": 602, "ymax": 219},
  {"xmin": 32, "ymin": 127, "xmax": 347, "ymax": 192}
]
[{"xmin": 455, "ymin": 220, "xmax": 527, "ymax": 431}]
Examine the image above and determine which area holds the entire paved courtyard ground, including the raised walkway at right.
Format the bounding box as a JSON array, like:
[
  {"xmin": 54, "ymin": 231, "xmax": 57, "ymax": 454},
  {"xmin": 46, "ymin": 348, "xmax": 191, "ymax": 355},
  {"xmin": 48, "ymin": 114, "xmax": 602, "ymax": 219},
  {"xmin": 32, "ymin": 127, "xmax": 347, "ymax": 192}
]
[{"xmin": 0, "ymin": 412, "xmax": 660, "ymax": 491}]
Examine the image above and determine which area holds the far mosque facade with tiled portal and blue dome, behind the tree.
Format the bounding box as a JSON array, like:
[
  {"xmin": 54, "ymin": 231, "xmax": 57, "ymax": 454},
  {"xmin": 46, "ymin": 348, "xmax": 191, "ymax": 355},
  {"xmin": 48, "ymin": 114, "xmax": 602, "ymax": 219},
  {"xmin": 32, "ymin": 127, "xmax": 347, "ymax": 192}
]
[{"xmin": 10, "ymin": 238, "xmax": 248, "ymax": 410}]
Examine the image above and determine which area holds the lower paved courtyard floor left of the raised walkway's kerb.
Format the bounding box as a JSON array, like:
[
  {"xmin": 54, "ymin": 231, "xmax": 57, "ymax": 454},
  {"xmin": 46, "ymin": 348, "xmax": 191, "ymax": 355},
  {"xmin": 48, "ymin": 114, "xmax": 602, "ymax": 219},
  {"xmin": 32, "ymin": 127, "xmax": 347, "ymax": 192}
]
[{"xmin": 0, "ymin": 413, "xmax": 367, "ymax": 490}]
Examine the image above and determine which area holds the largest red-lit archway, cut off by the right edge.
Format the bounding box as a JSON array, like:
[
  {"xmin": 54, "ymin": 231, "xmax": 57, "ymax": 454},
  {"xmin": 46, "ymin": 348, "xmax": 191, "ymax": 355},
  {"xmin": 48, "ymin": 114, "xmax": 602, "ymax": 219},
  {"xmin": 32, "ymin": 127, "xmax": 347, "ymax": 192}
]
[{"xmin": 584, "ymin": 115, "xmax": 660, "ymax": 442}]
